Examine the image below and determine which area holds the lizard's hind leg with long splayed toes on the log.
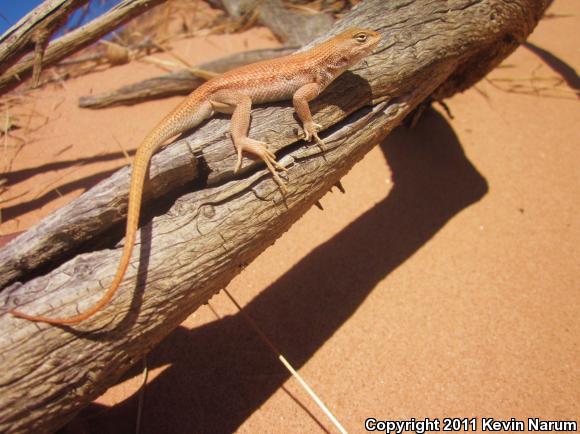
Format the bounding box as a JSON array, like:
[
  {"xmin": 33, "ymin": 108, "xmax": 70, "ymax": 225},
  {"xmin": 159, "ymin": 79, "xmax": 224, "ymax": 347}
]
[{"xmin": 209, "ymin": 89, "xmax": 287, "ymax": 192}]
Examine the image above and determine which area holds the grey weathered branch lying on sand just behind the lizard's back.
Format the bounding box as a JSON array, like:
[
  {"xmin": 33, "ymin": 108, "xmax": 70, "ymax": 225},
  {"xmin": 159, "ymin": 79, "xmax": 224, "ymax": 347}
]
[{"xmin": 79, "ymin": 47, "xmax": 296, "ymax": 109}]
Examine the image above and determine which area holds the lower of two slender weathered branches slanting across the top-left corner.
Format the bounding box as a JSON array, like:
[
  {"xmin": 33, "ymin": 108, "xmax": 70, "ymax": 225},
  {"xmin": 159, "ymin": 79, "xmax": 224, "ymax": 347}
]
[{"xmin": 0, "ymin": 0, "xmax": 166, "ymax": 93}]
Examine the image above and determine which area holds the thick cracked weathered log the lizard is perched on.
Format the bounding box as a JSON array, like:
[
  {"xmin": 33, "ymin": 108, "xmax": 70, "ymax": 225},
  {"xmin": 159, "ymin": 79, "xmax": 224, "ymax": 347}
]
[{"xmin": 0, "ymin": 0, "xmax": 548, "ymax": 433}]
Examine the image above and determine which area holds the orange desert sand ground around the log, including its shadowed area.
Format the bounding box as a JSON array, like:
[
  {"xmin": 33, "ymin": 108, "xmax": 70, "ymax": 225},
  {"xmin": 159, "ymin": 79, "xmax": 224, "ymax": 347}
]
[{"xmin": 0, "ymin": 0, "xmax": 580, "ymax": 433}]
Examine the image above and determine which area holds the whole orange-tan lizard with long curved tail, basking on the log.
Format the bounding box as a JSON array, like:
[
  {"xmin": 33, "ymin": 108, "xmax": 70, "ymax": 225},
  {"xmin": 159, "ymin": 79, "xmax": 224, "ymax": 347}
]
[{"xmin": 10, "ymin": 28, "xmax": 381, "ymax": 324}]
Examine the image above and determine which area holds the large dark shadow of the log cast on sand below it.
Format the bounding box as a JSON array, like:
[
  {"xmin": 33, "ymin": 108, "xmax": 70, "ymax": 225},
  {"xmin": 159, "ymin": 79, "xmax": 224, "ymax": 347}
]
[{"xmin": 63, "ymin": 110, "xmax": 488, "ymax": 433}]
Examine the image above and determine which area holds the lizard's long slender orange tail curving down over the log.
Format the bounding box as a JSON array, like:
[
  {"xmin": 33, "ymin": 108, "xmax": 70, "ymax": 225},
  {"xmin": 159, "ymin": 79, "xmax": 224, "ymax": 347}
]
[{"xmin": 10, "ymin": 92, "xmax": 211, "ymax": 324}]
